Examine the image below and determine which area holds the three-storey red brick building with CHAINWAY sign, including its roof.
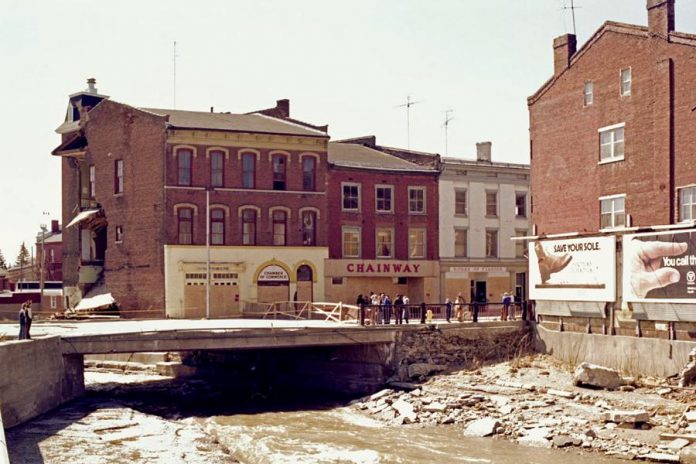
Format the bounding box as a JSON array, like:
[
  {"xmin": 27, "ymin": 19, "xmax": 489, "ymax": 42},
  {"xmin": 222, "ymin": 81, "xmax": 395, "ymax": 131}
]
[{"xmin": 326, "ymin": 137, "xmax": 440, "ymax": 303}]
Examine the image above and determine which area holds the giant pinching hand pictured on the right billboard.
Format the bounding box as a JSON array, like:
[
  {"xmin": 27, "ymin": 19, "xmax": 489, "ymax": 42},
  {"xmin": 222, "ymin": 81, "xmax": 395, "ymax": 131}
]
[{"xmin": 626, "ymin": 239, "xmax": 688, "ymax": 298}]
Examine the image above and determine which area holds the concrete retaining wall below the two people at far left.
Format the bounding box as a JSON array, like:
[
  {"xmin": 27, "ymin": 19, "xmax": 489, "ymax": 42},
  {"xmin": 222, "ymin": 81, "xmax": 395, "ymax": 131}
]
[{"xmin": 0, "ymin": 337, "xmax": 85, "ymax": 428}]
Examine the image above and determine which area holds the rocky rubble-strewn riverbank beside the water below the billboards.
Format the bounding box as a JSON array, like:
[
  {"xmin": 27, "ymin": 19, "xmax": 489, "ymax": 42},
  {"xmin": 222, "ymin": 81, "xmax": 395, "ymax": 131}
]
[{"xmin": 353, "ymin": 355, "xmax": 696, "ymax": 463}]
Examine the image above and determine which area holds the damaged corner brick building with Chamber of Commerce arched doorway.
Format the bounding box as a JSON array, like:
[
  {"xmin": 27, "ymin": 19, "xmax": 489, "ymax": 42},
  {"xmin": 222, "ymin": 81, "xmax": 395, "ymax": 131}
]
[{"xmin": 53, "ymin": 80, "xmax": 329, "ymax": 317}]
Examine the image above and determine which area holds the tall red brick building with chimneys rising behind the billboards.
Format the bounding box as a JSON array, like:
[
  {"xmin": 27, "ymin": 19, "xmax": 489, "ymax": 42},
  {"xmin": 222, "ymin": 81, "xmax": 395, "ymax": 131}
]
[{"xmin": 528, "ymin": 0, "xmax": 696, "ymax": 234}]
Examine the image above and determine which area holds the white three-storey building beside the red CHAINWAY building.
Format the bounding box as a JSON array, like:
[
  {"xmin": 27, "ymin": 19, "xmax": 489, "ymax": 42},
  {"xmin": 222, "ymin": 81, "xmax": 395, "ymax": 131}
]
[{"xmin": 439, "ymin": 142, "xmax": 531, "ymax": 303}]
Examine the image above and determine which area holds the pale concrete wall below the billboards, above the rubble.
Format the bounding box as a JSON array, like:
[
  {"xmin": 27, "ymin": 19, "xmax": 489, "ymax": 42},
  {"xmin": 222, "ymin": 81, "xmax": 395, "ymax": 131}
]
[{"xmin": 534, "ymin": 324, "xmax": 696, "ymax": 377}]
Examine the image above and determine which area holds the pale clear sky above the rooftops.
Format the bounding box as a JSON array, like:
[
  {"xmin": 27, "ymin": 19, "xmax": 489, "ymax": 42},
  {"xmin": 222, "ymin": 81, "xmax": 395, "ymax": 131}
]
[{"xmin": 0, "ymin": 0, "xmax": 696, "ymax": 262}]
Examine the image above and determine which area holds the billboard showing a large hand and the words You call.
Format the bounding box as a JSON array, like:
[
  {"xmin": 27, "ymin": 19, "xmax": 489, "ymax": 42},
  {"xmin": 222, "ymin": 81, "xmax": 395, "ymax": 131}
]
[{"xmin": 623, "ymin": 229, "xmax": 696, "ymax": 303}]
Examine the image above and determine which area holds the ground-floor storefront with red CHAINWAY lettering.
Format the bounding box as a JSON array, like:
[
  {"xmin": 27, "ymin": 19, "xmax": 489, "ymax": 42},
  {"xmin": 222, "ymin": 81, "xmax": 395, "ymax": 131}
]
[{"xmin": 325, "ymin": 259, "xmax": 440, "ymax": 304}]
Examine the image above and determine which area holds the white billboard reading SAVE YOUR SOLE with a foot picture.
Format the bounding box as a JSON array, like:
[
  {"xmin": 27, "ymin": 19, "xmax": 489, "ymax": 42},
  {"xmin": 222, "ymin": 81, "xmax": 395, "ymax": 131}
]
[{"xmin": 528, "ymin": 237, "xmax": 616, "ymax": 301}]
